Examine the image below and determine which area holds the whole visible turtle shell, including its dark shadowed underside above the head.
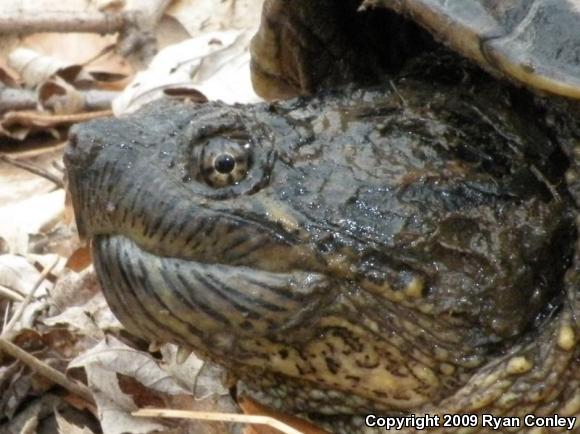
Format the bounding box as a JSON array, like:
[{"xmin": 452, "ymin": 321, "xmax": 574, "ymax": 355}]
[{"xmin": 252, "ymin": 0, "xmax": 580, "ymax": 99}]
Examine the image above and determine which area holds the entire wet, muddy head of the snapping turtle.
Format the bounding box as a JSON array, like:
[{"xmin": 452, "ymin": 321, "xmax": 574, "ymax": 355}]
[{"xmin": 65, "ymin": 82, "xmax": 572, "ymax": 413}]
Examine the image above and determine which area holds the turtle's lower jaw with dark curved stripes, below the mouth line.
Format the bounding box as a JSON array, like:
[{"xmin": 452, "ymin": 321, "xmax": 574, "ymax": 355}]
[{"xmin": 92, "ymin": 235, "xmax": 329, "ymax": 353}]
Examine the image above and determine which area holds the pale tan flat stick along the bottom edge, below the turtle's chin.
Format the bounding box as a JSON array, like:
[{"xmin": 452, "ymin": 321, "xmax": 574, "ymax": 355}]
[{"xmin": 132, "ymin": 408, "xmax": 303, "ymax": 434}]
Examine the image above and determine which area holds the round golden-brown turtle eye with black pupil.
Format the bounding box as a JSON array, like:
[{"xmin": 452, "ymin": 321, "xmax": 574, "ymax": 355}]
[{"xmin": 201, "ymin": 138, "xmax": 251, "ymax": 188}]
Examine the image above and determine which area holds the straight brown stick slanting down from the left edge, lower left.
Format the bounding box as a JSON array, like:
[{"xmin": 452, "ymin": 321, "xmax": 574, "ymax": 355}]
[{"xmin": 0, "ymin": 337, "xmax": 95, "ymax": 404}]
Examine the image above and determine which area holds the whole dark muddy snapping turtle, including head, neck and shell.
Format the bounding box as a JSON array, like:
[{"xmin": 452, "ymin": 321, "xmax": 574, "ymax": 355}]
[{"xmin": 65, "ymin": 0, "xmax": 580, "ymax": 432}]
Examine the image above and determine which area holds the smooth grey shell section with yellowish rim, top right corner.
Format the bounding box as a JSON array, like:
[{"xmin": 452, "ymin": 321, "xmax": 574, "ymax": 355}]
[{"xmin": 374, "ymin": 0, "xmax": 580, "ymax": 99}]
